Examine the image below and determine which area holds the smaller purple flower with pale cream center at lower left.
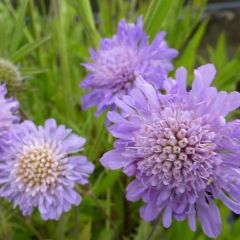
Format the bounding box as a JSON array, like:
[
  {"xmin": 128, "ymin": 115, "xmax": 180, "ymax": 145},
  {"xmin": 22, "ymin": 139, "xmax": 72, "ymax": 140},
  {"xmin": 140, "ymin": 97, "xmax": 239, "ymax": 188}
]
[{"xmin": 0, "ymin": 119, "xmax": 94, "ymax": 220}]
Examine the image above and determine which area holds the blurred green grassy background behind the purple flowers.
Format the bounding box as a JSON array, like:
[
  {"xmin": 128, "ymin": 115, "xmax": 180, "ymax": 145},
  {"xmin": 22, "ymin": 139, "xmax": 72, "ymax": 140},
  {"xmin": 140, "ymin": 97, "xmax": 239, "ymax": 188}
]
[{"xmin": 0, "ymin": 0, "xmax": 240, "ymax": 240}]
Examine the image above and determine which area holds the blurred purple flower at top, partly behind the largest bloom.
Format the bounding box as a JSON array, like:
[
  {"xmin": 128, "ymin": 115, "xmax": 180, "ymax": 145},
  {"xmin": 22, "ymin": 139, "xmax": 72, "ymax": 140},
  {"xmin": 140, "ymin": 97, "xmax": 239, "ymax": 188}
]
[{"xmin": 80, "ymin": 17, "xmax": 177, "ymax": 114}]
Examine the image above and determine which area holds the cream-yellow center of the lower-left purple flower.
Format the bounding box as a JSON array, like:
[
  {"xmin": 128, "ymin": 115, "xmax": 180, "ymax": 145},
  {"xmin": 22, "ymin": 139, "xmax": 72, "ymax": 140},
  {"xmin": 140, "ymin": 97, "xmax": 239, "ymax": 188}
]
[{"xmin": 15, "ymin": 146, "xmax": 62, "ymax": 194}]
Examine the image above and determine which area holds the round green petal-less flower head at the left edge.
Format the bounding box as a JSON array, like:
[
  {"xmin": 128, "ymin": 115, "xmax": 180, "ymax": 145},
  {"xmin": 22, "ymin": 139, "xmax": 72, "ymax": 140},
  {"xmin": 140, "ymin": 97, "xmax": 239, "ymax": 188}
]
[{"xmin": 0, "ymin": 58, "xmax": 23, "ymax": 87}]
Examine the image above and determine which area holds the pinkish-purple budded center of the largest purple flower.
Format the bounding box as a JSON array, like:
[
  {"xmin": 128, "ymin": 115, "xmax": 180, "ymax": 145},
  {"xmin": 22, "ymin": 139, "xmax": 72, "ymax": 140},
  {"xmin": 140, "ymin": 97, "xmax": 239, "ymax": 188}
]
[{"xmin": 132, "ymin": 108, "xmax": 219, "ymax": 193}]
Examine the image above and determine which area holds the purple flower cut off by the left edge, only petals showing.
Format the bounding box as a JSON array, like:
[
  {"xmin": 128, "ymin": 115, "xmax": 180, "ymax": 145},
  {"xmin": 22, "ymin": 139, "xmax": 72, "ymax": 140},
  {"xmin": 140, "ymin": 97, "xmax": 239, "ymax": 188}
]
[{"xmin": 0, "ymin": 85, "xmax": 18, "ymax": 153}]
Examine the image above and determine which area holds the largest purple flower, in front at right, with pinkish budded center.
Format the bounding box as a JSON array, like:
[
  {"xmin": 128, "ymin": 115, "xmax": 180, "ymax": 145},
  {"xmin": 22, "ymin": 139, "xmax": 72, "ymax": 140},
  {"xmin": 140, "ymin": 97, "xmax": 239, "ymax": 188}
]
[{"xmin": 101, "ymin": 64, "xmax": 240, "ymax": 237}]
